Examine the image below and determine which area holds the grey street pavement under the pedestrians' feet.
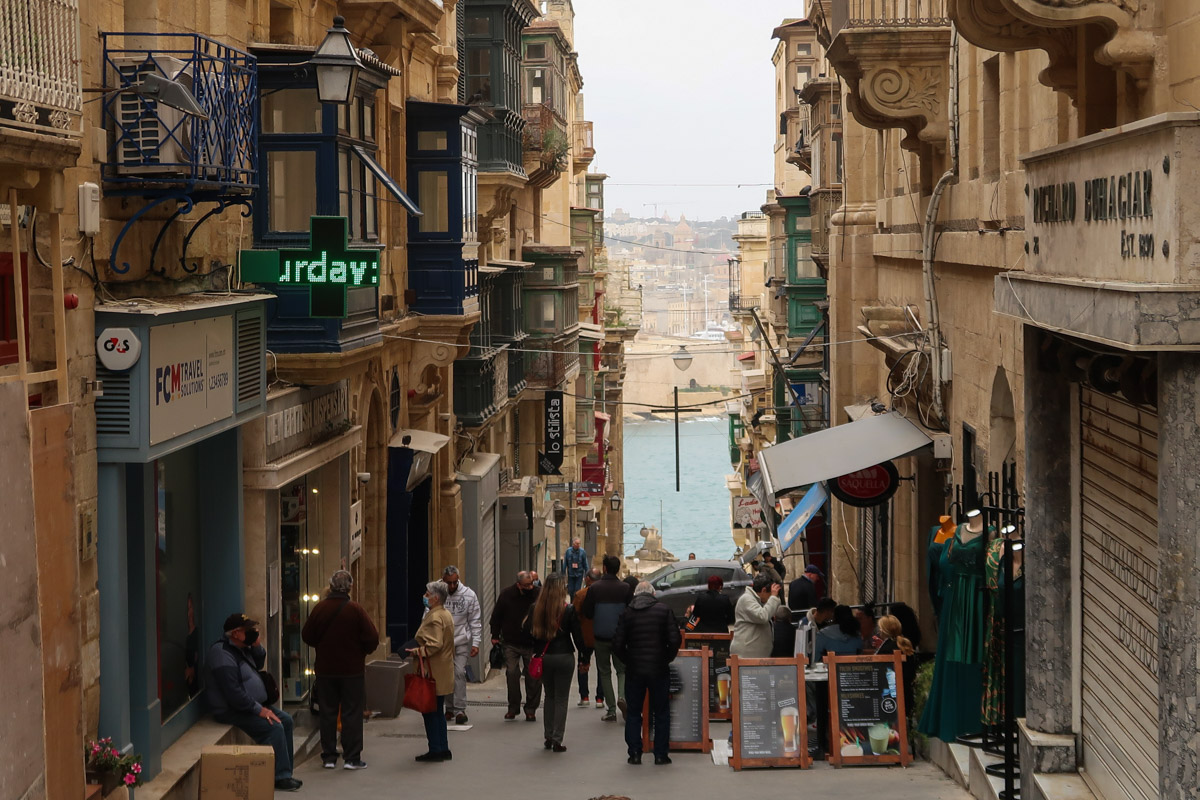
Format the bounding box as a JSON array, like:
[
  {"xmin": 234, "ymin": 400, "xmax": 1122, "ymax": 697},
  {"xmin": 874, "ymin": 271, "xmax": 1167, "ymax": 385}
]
[{"xmin": 295, "ymin": 674, "xmax": 972, "ymax": 800}]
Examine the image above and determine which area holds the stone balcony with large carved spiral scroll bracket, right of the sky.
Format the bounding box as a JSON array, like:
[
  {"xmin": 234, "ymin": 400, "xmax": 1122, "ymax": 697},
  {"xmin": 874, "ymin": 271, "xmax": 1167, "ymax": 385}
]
[{"xmin": 814, "ymin": 0, "xmax": 950, "ymax": 152}]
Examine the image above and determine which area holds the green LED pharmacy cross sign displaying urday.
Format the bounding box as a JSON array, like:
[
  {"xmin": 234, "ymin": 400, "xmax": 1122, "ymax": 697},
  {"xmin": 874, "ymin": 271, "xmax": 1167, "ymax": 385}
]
[{"xmin": 241, "ymin": 217, "xmax": 379, "ymax": 318}]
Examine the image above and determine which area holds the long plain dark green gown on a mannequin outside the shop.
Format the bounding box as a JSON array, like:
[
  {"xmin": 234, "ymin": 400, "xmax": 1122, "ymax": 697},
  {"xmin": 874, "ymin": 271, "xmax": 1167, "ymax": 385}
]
[{"xmin": 917, "ymin": 525, "xmax": 985, "ymax": 741}]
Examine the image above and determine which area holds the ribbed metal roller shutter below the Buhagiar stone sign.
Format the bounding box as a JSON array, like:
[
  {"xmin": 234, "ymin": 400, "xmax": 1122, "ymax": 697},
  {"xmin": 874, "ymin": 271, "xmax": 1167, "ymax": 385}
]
[{"xmin": 1080, "ymin": 387, "xmax": 1159, "ymax": 800}]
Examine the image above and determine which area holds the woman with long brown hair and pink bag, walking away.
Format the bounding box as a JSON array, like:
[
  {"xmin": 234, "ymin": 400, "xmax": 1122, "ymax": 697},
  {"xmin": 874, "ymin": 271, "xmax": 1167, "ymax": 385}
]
[{"xmin": 524, "ymin": 572, "xmax": 590, "ymax": 753}]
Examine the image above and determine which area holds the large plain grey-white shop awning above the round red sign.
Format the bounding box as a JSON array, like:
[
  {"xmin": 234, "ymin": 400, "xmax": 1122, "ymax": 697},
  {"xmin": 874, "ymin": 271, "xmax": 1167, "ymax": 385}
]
[{"xmin": 758, "ymin": 411, "xmax": 932, "ymax": 495}]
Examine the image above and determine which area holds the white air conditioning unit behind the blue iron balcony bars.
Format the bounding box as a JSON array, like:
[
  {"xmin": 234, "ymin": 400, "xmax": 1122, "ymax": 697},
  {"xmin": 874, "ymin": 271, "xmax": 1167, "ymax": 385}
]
[{"xmin": 109, "ymin": 55, "xmax": 194, "ymax": 175}]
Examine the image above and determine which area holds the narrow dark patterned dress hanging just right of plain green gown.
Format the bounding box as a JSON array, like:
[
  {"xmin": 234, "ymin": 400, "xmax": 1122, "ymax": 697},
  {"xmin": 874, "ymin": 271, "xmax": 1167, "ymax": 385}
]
[{"xmin": 983, "ymin": 539, "xmax": 1025, "ymax": 724}]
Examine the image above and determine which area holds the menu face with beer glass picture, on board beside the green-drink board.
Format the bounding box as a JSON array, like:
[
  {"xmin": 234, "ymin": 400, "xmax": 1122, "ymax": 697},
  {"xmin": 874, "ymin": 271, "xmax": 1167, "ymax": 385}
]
[{"xmin": 737, "ymin": 663, "xmax": 803, "ymax": 759}]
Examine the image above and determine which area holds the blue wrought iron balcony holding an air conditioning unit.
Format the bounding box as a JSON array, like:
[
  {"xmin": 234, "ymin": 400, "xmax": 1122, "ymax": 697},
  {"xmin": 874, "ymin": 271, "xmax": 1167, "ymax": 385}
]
[{"xmin": 101, "ymin": 34, "xmax": 259, "ymax": 196}]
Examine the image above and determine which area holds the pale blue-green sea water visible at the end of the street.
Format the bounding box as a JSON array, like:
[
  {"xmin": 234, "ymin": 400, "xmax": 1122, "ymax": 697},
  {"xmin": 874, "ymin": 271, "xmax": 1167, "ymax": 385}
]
[{"xmin": 624, "ymin": 416, "xmax": 734, "ymax": 560}]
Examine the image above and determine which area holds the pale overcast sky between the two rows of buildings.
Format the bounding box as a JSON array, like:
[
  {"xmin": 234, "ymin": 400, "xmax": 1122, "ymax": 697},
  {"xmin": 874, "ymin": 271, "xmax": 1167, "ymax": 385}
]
[{"xmin": 574, "ymin": 0, "xmax": 804, "ymax": 219}]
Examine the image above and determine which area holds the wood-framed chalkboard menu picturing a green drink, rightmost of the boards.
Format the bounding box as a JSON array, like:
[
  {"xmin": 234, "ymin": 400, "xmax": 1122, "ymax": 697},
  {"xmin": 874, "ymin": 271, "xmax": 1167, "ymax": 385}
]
[{"xmin": 826, "ymin": 652, "xmax": 912, "ymax": 766}]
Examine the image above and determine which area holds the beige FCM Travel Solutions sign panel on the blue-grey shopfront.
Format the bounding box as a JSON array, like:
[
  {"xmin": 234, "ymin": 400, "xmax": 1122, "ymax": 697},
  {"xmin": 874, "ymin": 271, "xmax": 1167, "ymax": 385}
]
[{"xmin": 150, "ymin": 317, "xmax": 234, "ymax": 445}]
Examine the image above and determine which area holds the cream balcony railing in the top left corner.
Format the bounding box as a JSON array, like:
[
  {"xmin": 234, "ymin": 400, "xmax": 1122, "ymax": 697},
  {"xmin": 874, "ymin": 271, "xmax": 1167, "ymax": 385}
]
[{"xmin": 0, "ymin": 0, "xmax": 83, "ymax": 136}]
